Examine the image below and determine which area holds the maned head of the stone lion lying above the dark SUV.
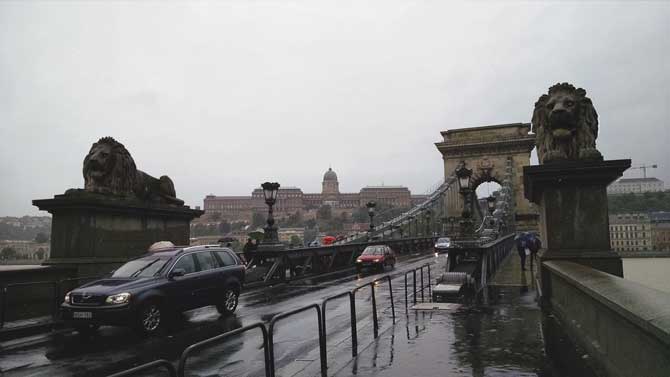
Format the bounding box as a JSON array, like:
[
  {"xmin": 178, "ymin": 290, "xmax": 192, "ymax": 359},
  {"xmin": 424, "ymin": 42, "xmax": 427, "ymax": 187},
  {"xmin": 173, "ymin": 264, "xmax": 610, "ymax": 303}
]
[{"xmin": 83, "ymin": 137, "xmax": 137, "ymax": 195}]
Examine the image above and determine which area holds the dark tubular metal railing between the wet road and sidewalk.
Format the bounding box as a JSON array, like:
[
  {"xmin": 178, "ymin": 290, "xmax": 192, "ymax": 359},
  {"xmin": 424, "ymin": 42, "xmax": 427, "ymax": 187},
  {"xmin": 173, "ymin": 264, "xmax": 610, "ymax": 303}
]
[{"xmin": 108, "ymin": 274, "xmax": 400, "ymax": 377}]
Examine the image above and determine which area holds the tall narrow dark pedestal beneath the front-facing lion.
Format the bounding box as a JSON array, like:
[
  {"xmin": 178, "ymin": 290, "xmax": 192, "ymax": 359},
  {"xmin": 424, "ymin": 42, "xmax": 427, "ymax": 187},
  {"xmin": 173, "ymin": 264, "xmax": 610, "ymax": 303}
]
[{"xmin": 523, "ymin": 160, "xmax": 631, "ymax": 277}]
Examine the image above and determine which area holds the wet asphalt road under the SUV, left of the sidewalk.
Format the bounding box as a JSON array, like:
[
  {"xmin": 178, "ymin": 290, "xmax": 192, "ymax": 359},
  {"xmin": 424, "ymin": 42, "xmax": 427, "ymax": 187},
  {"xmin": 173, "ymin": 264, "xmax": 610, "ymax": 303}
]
[{"xmin": 0, "ymin": 254, "xmax": 437, "ymax": 377}]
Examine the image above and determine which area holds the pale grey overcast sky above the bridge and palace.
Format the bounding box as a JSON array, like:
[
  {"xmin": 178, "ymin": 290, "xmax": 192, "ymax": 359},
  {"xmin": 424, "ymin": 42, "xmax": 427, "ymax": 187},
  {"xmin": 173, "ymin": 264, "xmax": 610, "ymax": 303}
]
[{"xmin": 0, "ymin": 0, "xmax": 670, "ymax": 216}]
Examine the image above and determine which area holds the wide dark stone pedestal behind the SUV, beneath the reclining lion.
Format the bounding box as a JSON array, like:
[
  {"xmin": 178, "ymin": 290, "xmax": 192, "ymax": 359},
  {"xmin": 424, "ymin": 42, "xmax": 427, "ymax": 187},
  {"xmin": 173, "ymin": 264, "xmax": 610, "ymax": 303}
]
[{"xmin": 33, "ymin": 190, "xmax": 204, "ymax": 276}]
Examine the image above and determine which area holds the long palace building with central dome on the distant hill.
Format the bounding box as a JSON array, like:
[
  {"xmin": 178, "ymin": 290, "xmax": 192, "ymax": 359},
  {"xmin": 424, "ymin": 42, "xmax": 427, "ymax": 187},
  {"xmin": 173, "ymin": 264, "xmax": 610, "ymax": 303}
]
[{"xmin": 204, "ymin": 168, "xmax": 426, "ymax": 221}]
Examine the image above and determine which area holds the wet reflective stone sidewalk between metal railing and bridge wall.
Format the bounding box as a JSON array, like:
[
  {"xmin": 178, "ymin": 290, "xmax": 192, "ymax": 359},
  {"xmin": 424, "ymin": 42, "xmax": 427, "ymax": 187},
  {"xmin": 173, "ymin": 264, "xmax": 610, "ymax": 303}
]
[{"xmin": 328, "ymin": 251, "xmax": 568, "ymax": 377}]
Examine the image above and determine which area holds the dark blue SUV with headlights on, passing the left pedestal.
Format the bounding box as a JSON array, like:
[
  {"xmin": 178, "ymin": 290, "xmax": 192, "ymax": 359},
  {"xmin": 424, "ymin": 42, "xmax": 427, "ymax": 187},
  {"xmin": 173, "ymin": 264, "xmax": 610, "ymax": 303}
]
[{"xmin": 61, "ymin": 245, "xmax": 245, "ymax": 335}]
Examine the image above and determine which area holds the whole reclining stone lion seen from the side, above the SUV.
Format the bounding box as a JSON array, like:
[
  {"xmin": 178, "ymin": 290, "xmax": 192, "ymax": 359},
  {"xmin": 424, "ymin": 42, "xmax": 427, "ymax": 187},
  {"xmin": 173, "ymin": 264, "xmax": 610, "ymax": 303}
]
[{"xmin": 83, "ymin": 137, "xmax": 184, "ymax": 205}]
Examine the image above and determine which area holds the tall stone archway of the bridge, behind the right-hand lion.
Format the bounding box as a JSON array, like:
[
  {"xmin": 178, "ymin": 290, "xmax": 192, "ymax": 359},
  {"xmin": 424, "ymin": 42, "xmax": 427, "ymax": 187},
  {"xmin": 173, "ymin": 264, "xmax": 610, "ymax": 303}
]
[{"xmin": 435, "ymin": 123, "xmax": 538, "ymax": 230}]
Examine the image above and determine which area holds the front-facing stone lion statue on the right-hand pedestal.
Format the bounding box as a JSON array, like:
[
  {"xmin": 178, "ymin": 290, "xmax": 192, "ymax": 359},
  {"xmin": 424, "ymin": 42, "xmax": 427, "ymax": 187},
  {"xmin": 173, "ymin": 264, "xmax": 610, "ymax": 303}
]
[{"xmin": 531, "ymin": 83, "xmax": 603, "ymax": 164}]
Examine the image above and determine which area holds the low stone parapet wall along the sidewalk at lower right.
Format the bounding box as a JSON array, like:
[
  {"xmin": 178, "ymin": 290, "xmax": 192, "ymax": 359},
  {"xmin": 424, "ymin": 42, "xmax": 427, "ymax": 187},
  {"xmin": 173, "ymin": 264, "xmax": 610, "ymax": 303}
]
[{"xmin": 542, "ymin": 261, "xmax": 670, "ymax": 377}]
